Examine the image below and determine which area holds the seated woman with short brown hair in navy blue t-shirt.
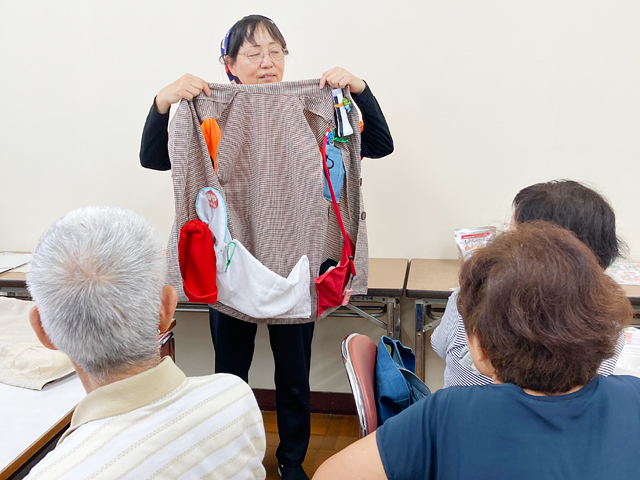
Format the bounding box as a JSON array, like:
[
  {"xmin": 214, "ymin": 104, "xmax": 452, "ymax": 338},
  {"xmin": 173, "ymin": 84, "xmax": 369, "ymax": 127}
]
[{"xmin": 314, "ymin": 222, "xmax": 640, "ymax": 480}]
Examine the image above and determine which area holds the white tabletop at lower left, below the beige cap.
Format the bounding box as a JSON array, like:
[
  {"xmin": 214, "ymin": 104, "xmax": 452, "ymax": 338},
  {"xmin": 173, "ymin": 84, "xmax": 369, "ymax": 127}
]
[{"xmin": 0, "ymin": 373, "xmax": 86, "ymax": 471}]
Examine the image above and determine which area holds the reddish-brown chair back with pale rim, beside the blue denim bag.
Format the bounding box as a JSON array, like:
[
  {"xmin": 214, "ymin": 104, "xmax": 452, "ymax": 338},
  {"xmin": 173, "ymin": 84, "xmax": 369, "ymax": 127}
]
[{"xmin": 342, "ymin": 333, "xmax": 378, "ymax": 437}]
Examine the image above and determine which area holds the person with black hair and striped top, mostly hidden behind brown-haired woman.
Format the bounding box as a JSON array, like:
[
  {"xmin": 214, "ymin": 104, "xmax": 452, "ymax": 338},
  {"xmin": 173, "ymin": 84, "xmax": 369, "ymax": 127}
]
[{"xmin": 431, "ymin": 180, "xmax": 624, "ymax": 388}]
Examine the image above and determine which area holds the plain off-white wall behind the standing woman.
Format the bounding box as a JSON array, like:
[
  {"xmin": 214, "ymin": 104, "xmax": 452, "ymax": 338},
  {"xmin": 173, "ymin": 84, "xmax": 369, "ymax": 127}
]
[{"xmin": 0, "ymin": 0, "xmax": 640, "ymax": 390}]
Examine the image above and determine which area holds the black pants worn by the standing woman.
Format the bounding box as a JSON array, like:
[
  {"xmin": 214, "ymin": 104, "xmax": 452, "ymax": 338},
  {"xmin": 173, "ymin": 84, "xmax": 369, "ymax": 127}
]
[{"xmin": 209, "ymin": 308, "xmax": 315, "ymax": 467}]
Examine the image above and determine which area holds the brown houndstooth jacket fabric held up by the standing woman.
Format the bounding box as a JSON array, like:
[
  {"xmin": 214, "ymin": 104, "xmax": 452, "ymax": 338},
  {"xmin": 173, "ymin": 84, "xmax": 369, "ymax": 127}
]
[{"xmin": 167, "ymin": 80, "xmax": 369, "ymax": 324}]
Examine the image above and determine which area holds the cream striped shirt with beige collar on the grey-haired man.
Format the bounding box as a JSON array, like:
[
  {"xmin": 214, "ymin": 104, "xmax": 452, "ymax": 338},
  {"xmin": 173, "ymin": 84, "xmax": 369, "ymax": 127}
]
[{"xmin": 27, "ymin": 357, "xmax": 266, "ymax": 480}]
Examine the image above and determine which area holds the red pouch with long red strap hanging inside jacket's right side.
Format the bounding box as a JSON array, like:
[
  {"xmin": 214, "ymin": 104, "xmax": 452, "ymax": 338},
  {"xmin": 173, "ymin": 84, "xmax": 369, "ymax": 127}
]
[{"xmin": 315, "ymin": 128, "xmax": 356, "ymax": 317}]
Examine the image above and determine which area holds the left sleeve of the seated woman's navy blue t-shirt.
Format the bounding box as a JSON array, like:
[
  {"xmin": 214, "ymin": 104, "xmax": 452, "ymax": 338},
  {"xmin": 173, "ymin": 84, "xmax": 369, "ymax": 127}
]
[{"xmin": 376, "ymin": 395, "xmax": 437, "ymax": 480}]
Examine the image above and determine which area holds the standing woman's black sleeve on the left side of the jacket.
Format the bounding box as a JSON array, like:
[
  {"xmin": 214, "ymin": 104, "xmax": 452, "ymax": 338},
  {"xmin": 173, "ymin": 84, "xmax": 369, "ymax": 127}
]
[{"xmin": 140, "ymin": 98, "xmax": 171, "ymax": 170}]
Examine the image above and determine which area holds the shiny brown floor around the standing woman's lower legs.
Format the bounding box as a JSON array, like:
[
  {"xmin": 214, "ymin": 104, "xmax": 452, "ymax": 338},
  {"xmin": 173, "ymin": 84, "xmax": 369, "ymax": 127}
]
[{"xmin": 262, "ymin": 412, "xmax": 360, "ymax": 480}]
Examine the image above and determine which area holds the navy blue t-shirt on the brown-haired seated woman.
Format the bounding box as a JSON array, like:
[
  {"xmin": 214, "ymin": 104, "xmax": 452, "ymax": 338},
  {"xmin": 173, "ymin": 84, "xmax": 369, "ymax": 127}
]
[{"xmin": 376, "ymin": 376, "xmax": 640, "ymax": 480}]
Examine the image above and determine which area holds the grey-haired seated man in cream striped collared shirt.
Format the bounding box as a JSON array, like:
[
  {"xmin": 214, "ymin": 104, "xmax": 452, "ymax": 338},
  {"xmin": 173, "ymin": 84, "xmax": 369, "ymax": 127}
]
[{"xmin": 27, "ymin": 207, "xmax": 266, "ymax": 480}]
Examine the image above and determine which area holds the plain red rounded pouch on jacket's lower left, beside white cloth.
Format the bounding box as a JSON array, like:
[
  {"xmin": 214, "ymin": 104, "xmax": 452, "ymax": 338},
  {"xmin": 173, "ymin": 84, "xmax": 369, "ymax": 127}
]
[{"xmin": 178, "ymin": 220, "xmax": 218, "ymax": 303}]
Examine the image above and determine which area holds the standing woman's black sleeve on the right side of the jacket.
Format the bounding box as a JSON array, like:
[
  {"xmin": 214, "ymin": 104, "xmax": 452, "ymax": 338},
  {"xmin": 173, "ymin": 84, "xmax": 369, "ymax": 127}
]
[{"xmin": 351, "ymin": 85, "xmax": 393, "ymax": 158}]
